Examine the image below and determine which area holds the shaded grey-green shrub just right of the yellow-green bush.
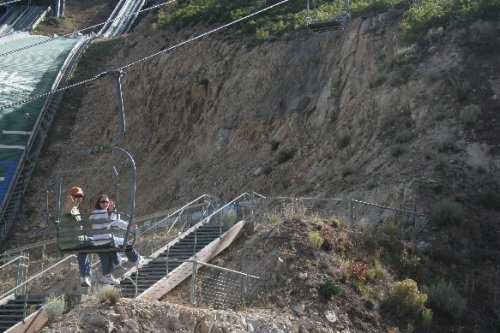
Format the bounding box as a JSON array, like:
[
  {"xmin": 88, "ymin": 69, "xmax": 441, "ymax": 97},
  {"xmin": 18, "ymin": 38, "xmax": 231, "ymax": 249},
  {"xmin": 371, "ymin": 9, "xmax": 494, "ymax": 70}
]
[{"xmin": 422, "ymin": 280, "xmax": 467, "ymax": 318}]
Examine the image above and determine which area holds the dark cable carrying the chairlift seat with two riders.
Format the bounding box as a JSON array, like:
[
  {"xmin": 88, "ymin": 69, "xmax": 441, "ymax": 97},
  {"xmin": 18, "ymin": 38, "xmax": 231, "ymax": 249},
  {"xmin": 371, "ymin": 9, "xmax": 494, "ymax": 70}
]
[{"xmin": 0, "ymin": 0, "xmax": 289, "ymax": 112}]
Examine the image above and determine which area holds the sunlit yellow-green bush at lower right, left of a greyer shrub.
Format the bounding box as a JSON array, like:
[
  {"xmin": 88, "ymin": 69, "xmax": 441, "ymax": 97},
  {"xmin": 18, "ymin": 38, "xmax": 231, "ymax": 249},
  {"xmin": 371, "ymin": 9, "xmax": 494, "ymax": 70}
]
[{"xmin": 383, "ymin": 279, "xmax": 427, "ymax": 317}]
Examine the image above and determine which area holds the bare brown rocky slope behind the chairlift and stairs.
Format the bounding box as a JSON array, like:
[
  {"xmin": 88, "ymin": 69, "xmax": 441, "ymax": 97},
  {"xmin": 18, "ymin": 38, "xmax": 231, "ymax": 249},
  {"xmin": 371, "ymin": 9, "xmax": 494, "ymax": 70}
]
[{"xmin": 17, "ymin": 9, "xmax": 498, "ymax": 222}]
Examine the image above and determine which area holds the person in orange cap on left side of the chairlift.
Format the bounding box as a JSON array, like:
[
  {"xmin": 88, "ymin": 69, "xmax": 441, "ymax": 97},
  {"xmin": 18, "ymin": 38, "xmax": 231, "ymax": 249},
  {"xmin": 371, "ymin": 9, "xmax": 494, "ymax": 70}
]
[{"xmin": 58, "ymin": 186, "xmax": 91, "ymax": 287}]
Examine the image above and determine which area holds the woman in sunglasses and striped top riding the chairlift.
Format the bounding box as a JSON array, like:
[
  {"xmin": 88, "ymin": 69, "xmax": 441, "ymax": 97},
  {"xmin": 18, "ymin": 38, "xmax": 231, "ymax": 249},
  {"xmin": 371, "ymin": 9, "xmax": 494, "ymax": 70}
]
[{"xmin": 89, "ymin": 194, "xmax": 142, "ymax": 285}]
